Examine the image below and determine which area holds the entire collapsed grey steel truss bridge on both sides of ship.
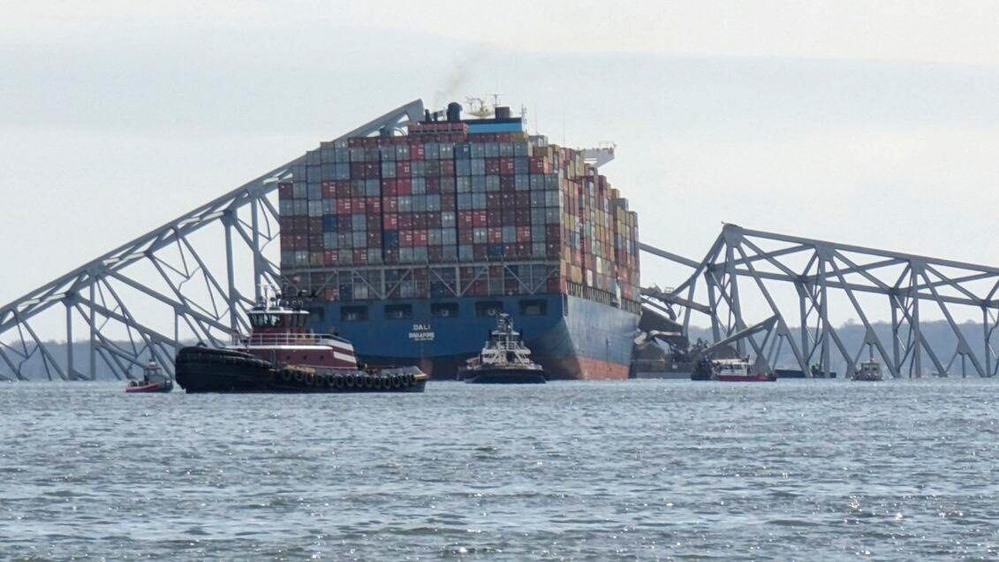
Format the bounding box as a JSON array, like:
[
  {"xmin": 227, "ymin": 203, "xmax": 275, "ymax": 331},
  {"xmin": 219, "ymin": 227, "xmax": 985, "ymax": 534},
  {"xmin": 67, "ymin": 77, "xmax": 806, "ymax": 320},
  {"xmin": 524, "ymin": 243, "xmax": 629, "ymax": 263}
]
[{"xmin": 0, "ymin": 100, "xmax": 999, "ymax": 380}]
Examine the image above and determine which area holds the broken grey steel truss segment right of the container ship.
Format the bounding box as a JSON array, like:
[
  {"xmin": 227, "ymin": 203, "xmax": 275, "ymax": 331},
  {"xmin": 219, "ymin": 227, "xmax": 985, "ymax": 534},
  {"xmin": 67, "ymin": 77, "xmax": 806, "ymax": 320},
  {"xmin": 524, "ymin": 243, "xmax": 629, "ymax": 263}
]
[{"xmin": 656, "ymin": 224, "xmax": 999, "ymax": 377}]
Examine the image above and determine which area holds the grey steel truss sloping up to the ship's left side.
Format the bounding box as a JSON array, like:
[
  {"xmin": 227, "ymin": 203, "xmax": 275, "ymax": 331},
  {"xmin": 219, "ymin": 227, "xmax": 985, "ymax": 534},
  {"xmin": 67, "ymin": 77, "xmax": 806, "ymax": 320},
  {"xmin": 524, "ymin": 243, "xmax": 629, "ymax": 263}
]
[{"xmin": 0, "ymin": 100, "xmax": 423, "ymax": 380}]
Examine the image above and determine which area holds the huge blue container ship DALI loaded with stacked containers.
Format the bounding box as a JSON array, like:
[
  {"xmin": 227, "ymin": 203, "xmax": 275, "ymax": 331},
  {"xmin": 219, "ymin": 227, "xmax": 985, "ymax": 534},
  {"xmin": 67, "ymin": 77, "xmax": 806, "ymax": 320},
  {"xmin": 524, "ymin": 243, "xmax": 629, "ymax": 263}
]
[{"xmin": 278, "ymin": 103, "xmax": 641, "ymax": 380}]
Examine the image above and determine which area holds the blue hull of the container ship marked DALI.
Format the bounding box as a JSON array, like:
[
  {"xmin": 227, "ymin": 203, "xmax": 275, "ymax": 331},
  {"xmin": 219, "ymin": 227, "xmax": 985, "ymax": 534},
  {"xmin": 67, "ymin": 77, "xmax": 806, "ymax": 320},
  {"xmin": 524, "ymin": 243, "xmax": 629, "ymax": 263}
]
[{"xmin": 309, "ymin": 294, "xmax": 639, "ymax": 380}]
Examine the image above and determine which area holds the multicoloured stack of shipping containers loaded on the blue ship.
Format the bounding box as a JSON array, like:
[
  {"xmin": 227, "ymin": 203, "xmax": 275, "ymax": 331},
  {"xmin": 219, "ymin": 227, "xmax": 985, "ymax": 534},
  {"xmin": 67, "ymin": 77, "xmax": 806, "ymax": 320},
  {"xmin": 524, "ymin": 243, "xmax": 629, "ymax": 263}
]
[{"xmin": 279, "ymin": 116, "xmax": 639, "ymax": 312}]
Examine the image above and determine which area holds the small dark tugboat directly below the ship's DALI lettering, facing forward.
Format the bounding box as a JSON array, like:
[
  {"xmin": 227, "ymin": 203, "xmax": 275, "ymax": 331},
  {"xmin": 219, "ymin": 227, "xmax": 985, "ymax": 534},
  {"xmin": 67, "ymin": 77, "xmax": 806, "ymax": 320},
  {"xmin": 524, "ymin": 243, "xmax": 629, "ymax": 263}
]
[{"xmin": 459, "ymin": 313, "xmax": 546, "ymax": 384}]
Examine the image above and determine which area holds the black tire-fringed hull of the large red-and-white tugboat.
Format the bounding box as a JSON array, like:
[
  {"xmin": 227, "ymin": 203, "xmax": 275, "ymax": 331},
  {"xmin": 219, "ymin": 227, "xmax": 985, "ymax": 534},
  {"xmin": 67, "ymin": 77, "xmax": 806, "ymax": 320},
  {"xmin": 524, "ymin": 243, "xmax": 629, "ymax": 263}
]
[{"xmin": 174, "ymin": 347, "xmax": 428, "ymax": 393}]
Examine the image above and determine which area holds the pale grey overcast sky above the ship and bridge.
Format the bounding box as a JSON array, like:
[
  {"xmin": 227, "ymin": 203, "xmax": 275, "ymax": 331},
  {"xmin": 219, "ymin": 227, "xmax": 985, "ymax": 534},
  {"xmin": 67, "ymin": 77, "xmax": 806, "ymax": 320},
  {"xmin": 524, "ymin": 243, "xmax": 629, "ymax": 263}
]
[{"xmin": 0, "ymin": 0, "xmax": 999, "ymax": 318}]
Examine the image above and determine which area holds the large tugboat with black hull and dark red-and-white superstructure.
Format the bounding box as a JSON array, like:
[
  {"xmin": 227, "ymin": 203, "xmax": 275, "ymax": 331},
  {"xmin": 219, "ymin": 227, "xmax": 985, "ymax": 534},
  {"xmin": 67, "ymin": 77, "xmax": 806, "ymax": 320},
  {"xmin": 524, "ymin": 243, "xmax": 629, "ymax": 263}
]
[{"xmin": 176, "ymin": 290, "xmax": 429, "ymax": 393}]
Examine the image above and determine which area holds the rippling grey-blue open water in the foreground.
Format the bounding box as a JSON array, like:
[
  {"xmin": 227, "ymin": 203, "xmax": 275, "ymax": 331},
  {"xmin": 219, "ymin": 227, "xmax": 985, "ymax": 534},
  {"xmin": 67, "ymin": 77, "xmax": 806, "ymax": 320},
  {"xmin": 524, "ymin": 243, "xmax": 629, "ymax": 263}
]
[{"xmin": 0, "ymin": 379, "xmax": 999, "ymax": 561}]
